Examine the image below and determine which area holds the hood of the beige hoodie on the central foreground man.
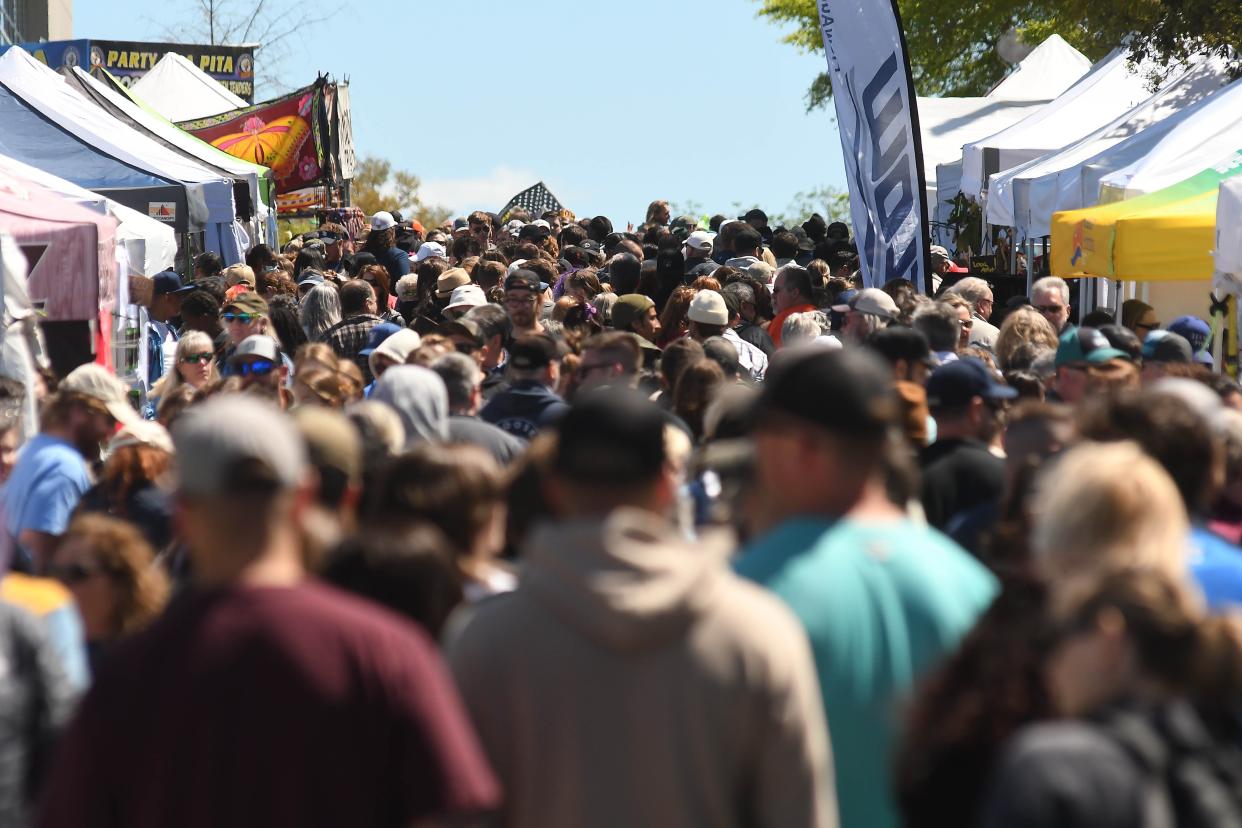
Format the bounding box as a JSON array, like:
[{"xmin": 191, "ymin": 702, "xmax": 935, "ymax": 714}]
[{"xmin": 522, "ymin": 509, "xmax": 733, "ymax": 652}]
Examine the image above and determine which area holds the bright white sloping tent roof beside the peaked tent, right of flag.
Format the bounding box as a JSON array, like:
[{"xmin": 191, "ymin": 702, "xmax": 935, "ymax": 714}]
[{"xmin": 961, "ymin": 50, "xmax": 1151, "ymax": 197}]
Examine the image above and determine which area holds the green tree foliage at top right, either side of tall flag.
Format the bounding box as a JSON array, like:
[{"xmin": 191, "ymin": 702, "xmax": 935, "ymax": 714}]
[{"xmin": 759, "ymin": 0, "xmax": 1242, "ymax": 109}]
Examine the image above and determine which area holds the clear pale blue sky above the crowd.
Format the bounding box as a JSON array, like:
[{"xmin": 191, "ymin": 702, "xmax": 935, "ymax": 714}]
[{"xmin": 73, "ymin": 0, "xmax": 845, "ymax": 223}]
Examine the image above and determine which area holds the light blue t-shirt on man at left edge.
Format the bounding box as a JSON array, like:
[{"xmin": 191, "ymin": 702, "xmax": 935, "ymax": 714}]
[{"xmin": 4, "ymin": 434, "xmax": 91, "ymax": 562}]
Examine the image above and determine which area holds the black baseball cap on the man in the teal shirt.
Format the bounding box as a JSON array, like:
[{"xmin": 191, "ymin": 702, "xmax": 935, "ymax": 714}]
[{"xmin": 754, "ymin": 348, "xmax": 898, "ymax": 437}]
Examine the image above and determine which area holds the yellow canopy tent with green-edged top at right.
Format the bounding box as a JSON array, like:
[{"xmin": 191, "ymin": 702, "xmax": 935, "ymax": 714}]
[{"xmin": 1049, "ymin": 153, "xmax": 1242, "ymax": 282}]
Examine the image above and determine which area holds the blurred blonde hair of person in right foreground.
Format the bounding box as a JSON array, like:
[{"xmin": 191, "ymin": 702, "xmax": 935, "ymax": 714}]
[{"xmin": 1031, "ymin": 441, "xmax": 1190, "ymax": 588}]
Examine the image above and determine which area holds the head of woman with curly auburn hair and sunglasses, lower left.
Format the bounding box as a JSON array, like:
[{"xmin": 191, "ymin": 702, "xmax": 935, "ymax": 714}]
[{"xmin": 48, "ymin": 515, "xmax": 169, "ymax": 673}]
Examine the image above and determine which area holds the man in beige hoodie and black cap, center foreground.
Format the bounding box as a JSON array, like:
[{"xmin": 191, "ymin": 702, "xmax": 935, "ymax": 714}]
[{"xmin": 448, "ymin": 389, "xmax": 836, "ymax": 828}]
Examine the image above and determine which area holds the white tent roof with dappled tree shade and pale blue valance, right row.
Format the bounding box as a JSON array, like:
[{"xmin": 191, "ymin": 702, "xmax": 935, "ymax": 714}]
[{"xmin": 987, "ymin": 58, "xmax": 1228, "ymax": 237}]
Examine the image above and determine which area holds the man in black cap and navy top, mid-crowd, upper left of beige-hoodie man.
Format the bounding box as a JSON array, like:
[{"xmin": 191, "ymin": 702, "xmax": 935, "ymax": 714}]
[{"xmin": 478, "ymin": 334, "xmax": 566, "ymax": 439}]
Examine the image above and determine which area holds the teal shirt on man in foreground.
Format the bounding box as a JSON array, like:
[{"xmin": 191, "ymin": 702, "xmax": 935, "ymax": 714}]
[{"xmin": 737, "ymin": 518, "xmax": 997, "ymax": 828}]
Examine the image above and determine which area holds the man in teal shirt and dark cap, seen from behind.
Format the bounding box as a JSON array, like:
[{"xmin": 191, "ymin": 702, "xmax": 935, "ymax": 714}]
[{"xmin": 737, "ymin": 348, "xmax": 996, "ymax": 828}]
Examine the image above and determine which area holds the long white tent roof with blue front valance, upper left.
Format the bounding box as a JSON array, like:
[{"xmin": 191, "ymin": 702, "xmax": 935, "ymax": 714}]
[{"xmin": 0, "ymin": 48, "xmax": 245, "ymax": 262}]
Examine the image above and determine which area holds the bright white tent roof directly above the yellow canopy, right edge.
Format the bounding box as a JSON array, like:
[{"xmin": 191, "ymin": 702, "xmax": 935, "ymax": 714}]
[{"xmin": 1088, "ymin": 81, "xmax": 1242, "ymax": 201}]
